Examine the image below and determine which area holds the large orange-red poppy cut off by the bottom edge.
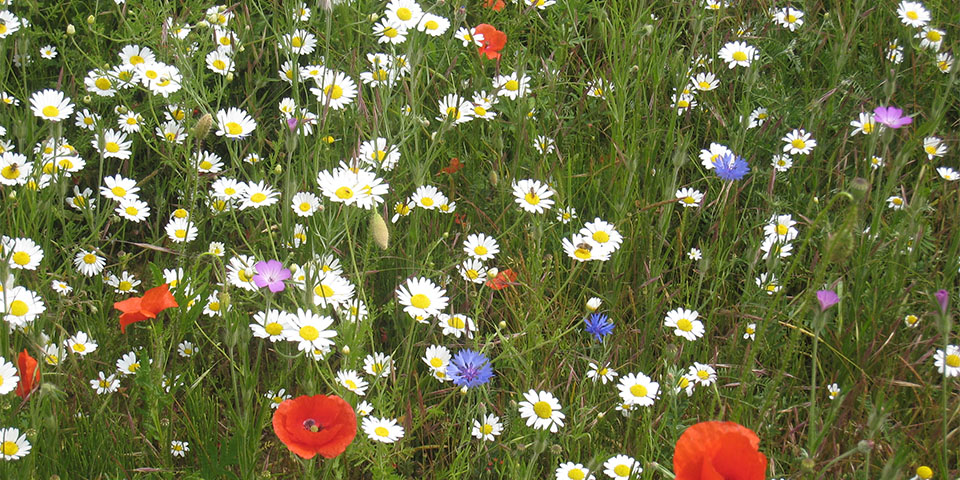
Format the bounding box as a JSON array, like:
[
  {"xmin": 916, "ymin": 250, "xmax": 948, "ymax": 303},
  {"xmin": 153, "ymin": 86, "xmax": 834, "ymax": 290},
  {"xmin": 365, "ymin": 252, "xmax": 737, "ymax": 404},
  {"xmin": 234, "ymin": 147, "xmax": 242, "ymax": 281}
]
[{"xmin": 673, "ymin": 422, "xmax": 767, "ymax": 480}]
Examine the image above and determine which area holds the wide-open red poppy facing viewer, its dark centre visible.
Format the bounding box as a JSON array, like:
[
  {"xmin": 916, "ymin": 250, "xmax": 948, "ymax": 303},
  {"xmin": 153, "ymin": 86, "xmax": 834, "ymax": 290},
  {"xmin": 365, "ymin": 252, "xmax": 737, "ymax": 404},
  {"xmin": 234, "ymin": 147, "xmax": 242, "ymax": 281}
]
[{"xmin": 273, "ymin": 395, "xmax": 357, "ymax": 458}]
